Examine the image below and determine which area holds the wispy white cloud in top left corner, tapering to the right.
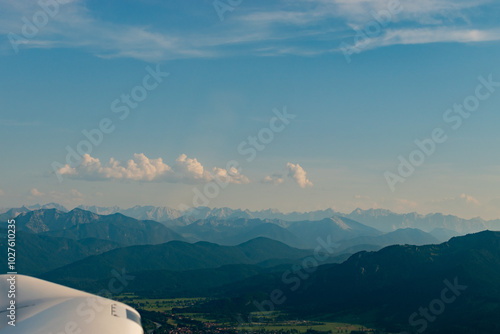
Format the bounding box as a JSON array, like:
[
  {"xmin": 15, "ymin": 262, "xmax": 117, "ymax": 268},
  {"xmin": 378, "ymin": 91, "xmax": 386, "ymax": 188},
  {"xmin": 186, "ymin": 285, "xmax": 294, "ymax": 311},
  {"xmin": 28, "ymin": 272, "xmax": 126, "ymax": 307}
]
[{"xmin": 0, "ymin": 0, "xmax": 213, "ymax": 61}]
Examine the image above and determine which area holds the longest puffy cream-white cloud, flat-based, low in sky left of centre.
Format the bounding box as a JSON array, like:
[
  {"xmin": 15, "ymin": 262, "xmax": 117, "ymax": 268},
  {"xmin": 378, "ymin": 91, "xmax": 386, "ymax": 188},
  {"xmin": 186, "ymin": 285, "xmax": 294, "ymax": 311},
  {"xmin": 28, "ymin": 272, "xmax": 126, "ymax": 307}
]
[{"xmin": 57, "ymin": 153, "xmax": 249, "ymax": 184}]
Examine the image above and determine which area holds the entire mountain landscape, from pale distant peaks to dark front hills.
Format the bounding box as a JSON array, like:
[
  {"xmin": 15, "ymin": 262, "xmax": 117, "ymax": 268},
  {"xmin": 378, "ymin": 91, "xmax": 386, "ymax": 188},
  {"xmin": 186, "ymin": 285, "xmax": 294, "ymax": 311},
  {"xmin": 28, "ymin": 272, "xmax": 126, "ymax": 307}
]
[{"xmin": 0, "ymin": 205, "xmax": 500, "ymax": 333}]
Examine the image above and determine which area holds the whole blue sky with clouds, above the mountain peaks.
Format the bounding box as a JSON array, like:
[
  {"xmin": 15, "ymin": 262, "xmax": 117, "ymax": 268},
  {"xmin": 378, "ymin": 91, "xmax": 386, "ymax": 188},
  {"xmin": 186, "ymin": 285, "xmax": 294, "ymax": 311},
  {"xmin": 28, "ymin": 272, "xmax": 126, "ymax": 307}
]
[{"xmin": 0, "ymin": 0, "xmax": 500, "ymax": 218}]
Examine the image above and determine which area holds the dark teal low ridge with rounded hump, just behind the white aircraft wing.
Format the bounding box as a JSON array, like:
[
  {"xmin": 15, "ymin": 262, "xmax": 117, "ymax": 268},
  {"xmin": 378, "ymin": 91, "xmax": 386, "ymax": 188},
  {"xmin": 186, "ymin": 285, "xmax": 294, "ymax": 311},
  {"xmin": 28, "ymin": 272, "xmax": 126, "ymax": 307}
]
[{"xmin": 43, "ymin": 238, "xmax": 310, "ymax": 285}]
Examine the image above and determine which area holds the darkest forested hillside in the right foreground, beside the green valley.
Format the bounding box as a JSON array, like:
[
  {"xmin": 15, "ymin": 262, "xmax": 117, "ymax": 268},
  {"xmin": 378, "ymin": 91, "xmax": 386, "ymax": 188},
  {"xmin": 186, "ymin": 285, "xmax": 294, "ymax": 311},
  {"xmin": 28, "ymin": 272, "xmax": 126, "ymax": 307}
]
[{"xmin": 194, "ymin": 231, "xmax": 500, "ymax": 333}]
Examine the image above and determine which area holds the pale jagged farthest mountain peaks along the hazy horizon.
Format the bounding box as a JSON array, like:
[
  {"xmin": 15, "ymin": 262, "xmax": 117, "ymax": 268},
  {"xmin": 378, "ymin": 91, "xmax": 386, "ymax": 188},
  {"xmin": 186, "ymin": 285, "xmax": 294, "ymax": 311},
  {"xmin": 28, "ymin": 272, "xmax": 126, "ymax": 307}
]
[{"xmin": 4, "ymin": 203, "xmax": 500, "ymax": 235}]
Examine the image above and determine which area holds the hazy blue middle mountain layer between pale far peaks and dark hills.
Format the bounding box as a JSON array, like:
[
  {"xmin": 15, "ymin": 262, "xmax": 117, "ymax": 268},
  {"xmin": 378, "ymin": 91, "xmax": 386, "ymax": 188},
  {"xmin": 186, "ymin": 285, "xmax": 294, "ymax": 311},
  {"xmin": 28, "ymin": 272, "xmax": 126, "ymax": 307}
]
[{"xmin": 11, "ymin": 209, "xmax": 453, "ymax": 254}]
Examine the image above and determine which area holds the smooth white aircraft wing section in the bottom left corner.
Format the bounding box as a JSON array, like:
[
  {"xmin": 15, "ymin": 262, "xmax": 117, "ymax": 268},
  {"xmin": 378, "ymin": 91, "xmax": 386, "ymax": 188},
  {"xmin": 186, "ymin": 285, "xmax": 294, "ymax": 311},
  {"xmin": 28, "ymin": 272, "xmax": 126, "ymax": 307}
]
[{"xmin": 0, "ymin": 275, "xmax": 144, "ymax": 334}]
